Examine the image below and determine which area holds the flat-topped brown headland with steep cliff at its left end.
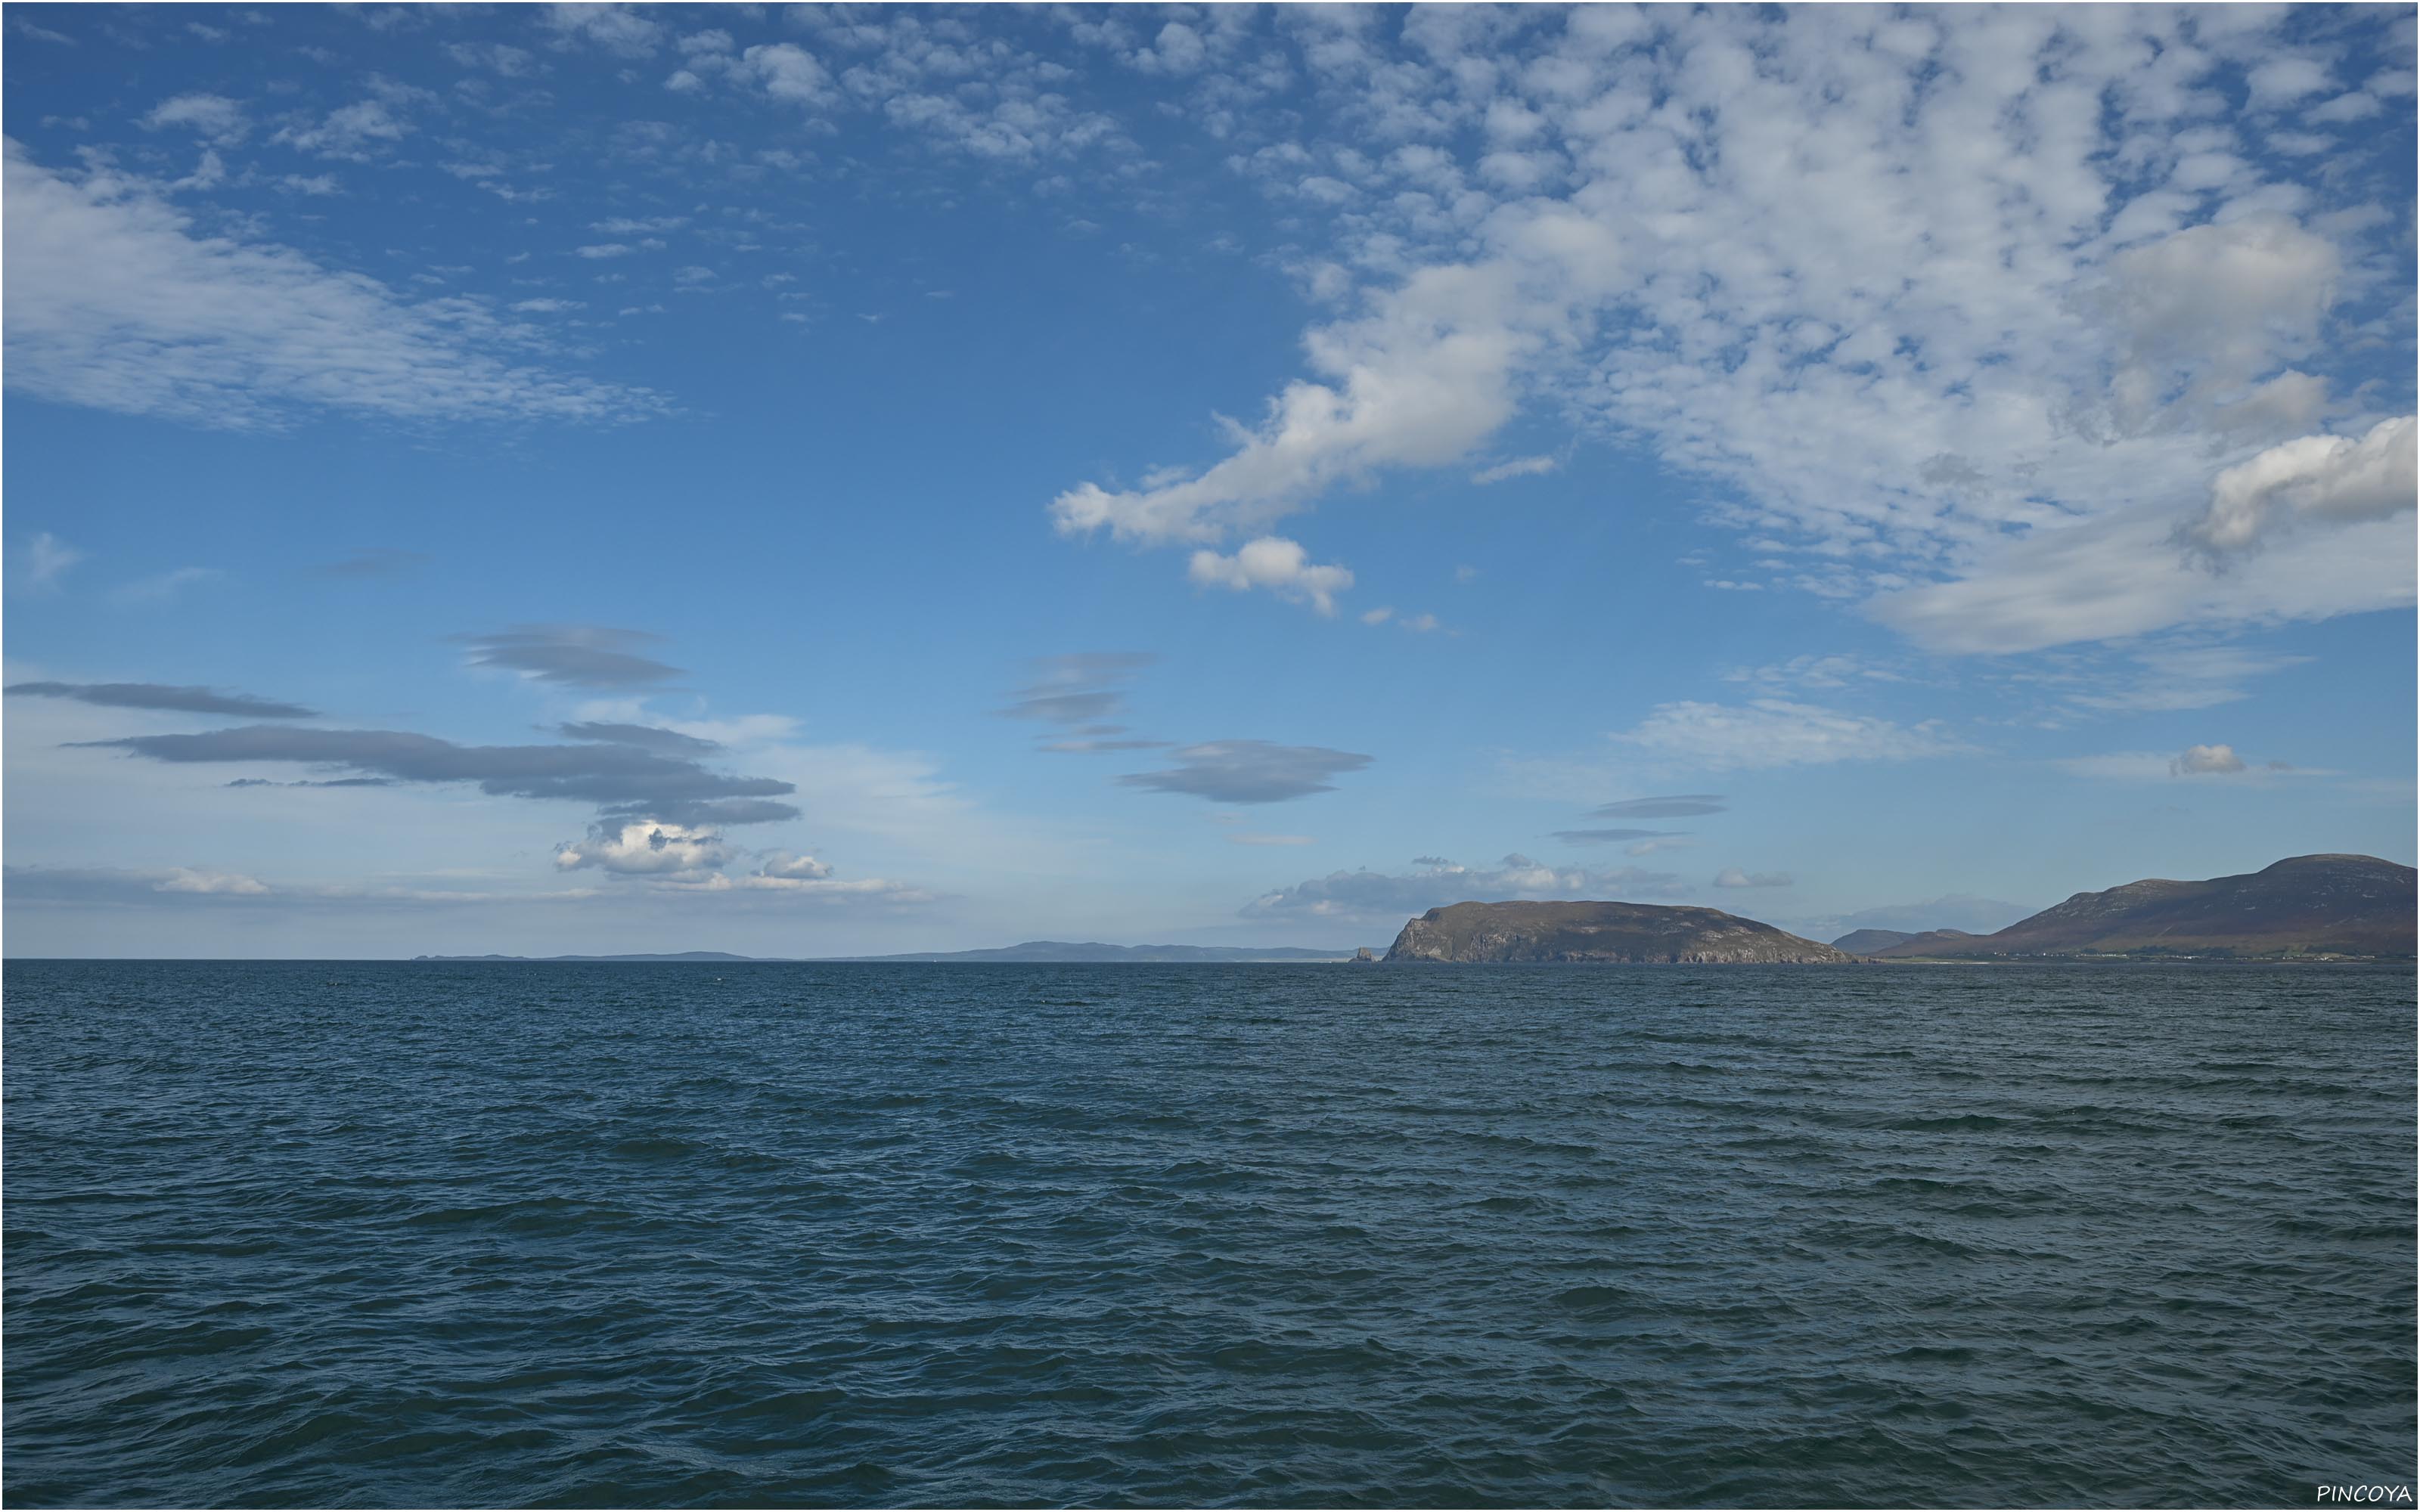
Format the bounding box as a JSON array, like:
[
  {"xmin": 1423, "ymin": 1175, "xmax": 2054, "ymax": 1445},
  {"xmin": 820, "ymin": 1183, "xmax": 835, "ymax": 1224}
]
[{"xmin": 1387, "ymin": 903, "xmax": 1849, "ymax": 965}]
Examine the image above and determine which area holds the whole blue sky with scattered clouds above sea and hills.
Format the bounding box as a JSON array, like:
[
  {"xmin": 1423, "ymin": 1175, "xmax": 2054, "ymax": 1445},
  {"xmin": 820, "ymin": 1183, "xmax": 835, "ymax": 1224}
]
[{"xmin": 0, "ymin": 5, "xmax": 2415, "ymax": 958}]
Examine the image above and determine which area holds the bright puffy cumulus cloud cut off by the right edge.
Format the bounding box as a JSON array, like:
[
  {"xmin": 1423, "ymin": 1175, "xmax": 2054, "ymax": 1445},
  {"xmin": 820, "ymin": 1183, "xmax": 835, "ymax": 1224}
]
[{"xmin": 2183, "ymin": 416, "xmax": 2420, "ymax": 556}]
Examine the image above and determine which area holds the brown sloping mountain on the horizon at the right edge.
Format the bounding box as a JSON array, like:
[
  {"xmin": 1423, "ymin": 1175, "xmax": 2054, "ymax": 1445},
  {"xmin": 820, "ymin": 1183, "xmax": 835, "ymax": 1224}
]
[{"xmin": 1871, "ymin": 857, "xmax": 2420, "ymax": 958}]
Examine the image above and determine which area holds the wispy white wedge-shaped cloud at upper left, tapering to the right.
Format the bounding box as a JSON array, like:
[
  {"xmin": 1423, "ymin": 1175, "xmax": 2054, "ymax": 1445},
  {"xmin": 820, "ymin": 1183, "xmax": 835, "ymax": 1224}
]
[{"xmin": 5, "ymin": 143, "xmax": 658, "ymax": 426}]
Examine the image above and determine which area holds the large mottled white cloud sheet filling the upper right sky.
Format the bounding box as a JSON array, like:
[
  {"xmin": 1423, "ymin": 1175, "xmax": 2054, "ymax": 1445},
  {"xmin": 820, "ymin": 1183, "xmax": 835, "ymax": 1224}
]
[{"xmin": 1050, "ymin": 8, "xmax": 2408, "ymax": 651}]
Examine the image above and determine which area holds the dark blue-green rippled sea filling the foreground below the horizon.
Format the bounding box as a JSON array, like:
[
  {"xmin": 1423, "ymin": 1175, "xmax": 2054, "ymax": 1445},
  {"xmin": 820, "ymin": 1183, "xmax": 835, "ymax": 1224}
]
[{"xmin": 0, "ymin": 963, "xmax": 2415, "ymax": 1507}]
